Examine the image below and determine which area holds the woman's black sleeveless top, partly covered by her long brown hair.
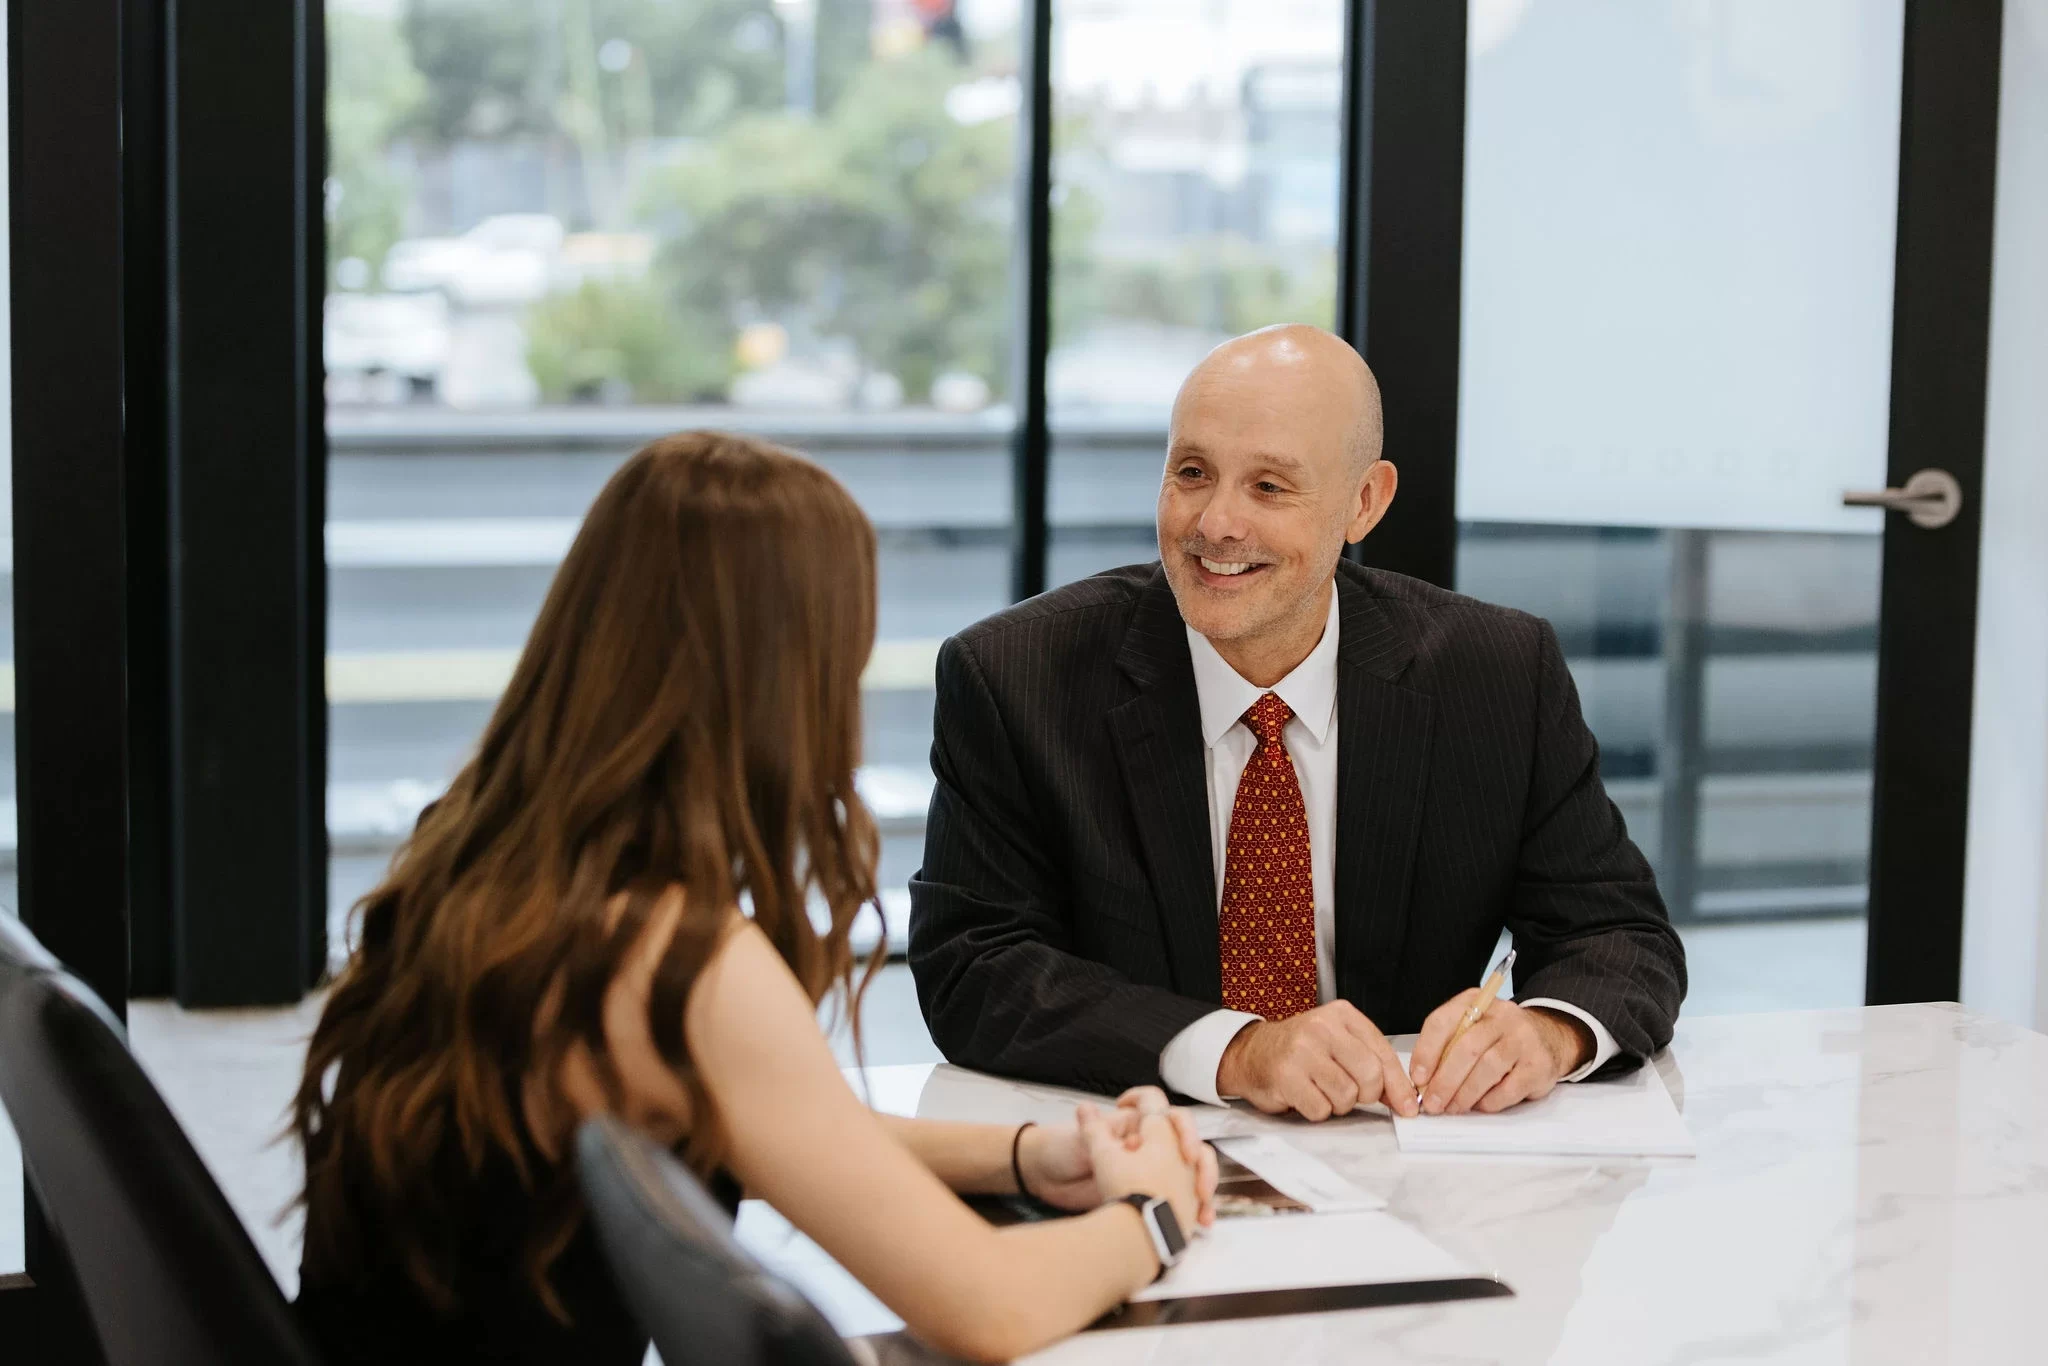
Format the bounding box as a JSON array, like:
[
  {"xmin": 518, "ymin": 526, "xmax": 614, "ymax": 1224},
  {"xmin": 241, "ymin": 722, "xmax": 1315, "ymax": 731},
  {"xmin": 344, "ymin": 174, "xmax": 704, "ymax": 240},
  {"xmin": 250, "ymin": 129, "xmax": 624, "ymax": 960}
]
[{"xmin": 295, "ymin": 1130, "xmax": 739, "ymax": 1366}]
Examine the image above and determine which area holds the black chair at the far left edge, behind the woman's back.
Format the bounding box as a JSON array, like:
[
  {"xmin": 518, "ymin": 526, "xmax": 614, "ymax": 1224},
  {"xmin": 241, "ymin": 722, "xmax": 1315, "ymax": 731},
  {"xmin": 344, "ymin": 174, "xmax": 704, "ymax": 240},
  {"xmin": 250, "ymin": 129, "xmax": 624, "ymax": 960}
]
[{"xmin": 0, "ymin": 913, "xmax": 317, "ymax": 1366}]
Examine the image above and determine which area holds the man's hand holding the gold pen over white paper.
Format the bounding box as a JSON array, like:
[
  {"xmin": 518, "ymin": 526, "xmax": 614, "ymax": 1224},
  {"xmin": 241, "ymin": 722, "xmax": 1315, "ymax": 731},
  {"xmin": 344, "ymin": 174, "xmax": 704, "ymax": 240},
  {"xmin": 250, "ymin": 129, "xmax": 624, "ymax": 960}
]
[{"xmin": 1409, "ymin": 987, "xmax": 1593, "ymax": 1114}]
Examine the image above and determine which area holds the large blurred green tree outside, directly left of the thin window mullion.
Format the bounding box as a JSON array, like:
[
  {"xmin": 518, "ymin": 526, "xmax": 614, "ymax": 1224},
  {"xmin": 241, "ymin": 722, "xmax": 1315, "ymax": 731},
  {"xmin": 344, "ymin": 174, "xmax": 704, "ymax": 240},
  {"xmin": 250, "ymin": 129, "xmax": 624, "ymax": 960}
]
[{"xmin": 645, "ymin": 47, "xmax": 1016, "ymax": 401}]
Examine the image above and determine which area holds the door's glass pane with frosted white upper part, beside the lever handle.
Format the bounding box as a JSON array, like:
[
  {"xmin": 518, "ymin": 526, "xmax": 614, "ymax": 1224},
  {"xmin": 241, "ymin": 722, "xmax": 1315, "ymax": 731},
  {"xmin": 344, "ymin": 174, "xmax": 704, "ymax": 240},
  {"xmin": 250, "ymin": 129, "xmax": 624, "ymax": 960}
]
[{"xmin": 1458, "ymin": 0, "xmax": 1903, "ymax": 1014}]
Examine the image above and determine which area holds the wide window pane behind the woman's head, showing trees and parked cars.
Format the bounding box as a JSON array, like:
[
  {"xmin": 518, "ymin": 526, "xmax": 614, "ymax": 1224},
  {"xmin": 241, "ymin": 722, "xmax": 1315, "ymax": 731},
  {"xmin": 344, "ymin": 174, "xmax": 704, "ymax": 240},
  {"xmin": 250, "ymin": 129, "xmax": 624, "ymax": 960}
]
[{"xmin": 326, "ymin": 0, "xmax": 1020, "ymax": 946}]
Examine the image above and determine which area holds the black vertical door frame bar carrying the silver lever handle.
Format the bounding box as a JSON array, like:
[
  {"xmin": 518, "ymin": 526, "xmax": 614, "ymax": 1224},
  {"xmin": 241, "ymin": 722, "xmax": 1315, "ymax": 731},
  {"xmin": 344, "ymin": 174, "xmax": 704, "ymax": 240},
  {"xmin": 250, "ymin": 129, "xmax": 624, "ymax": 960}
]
[{"xmin": 1864, "ymin": 0, "xmax": 2003, "ymax": 1006}]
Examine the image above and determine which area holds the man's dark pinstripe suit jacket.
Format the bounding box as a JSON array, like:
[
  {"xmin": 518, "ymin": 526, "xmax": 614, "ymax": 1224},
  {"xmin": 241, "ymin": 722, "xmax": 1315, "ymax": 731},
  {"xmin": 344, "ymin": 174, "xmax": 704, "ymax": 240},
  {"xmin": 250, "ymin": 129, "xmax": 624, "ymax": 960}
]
[{"xmin": 909, "ymin": 561, "xmax": 1686, "ymax": 1092}]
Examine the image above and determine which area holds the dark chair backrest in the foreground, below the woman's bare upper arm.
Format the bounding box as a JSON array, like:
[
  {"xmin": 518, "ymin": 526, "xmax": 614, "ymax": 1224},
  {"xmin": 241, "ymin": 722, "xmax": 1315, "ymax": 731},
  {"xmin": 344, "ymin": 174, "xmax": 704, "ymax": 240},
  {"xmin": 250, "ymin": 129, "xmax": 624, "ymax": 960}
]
[{"xmin": 575, "ymin": 1118, "xmax": 854, "ymax": 1366}]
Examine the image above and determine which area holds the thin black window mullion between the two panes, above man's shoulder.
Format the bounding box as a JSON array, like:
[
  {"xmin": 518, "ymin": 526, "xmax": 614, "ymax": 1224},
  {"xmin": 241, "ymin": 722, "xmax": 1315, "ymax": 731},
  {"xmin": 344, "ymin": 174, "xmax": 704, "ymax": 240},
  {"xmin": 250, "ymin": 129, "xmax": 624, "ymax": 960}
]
[{"xmin": 1010, "ymin": 0, "xmax": 1053, "ymax": 600}]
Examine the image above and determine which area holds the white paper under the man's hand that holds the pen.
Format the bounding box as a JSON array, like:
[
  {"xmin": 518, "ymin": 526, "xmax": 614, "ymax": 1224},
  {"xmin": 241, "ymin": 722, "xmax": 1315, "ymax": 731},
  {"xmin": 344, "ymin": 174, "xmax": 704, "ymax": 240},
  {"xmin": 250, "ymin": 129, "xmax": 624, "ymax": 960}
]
[{"xmin": 1395, "ymin": 1055, "xmax": 1698, "ymax": 1157}]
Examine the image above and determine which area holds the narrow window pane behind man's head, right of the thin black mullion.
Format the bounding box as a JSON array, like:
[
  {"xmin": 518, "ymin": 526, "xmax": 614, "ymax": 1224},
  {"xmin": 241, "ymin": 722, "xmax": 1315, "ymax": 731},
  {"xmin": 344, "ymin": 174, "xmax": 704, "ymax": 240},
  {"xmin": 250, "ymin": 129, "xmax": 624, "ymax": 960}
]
[{"xmin": 1047, "ymin": 0, "xmax": 1346, "ymax": 584}]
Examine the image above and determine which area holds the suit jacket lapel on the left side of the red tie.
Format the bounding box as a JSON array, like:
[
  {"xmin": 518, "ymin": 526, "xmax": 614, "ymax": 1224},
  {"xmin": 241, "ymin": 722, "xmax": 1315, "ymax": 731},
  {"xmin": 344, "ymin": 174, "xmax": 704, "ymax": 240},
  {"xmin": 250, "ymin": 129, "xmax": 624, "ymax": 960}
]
[{"xmin": 1108, "ymin": 569, "xmax": 1223, "ymax": 1001}]
